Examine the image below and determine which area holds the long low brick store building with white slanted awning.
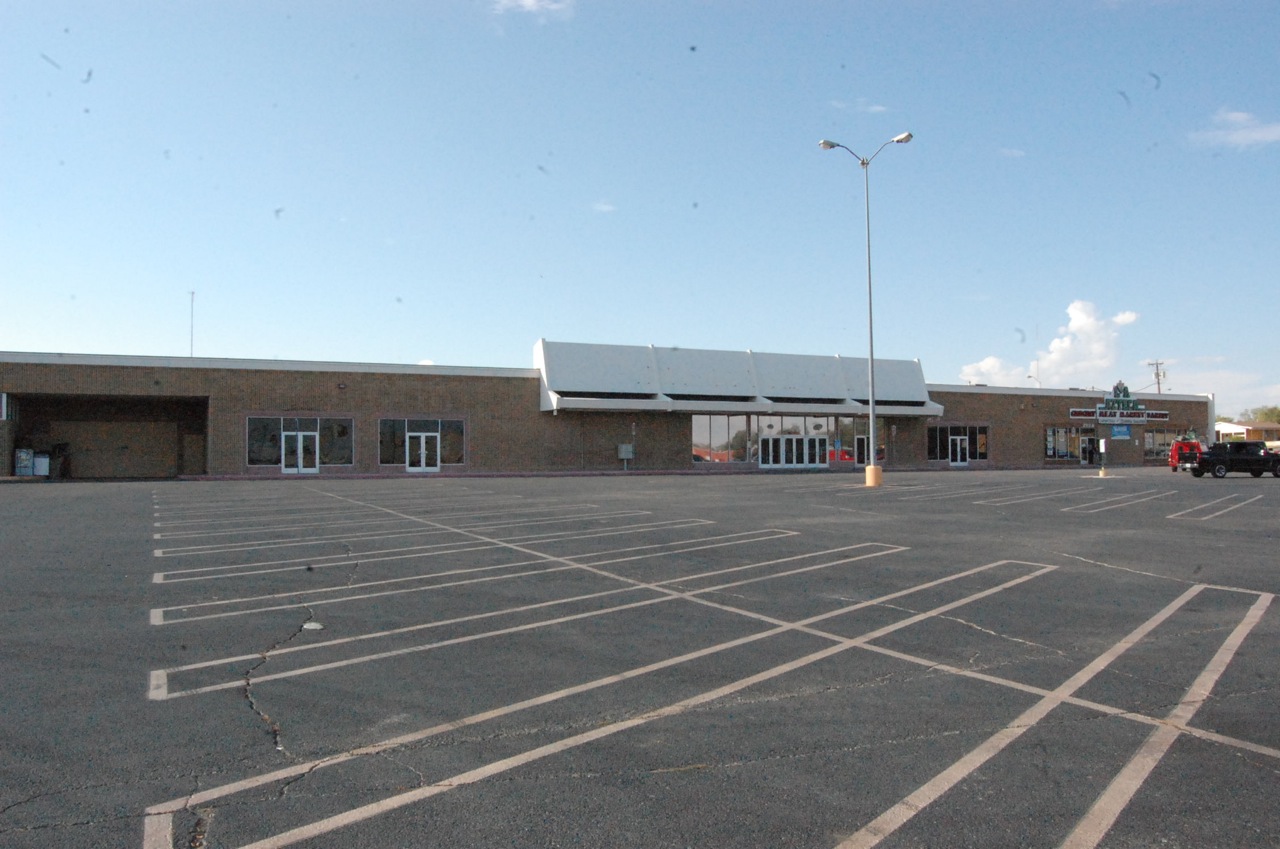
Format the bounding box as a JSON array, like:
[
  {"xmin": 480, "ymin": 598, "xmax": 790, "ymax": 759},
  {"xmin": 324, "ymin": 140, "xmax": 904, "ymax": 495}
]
[{"xmin": 0, "ymin": 341, "xmax": 1213, "ymax": 479}]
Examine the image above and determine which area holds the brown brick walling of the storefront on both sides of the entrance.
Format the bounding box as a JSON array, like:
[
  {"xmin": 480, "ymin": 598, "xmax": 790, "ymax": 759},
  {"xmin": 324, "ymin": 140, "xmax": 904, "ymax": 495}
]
[{"xmin": 0, "ymin": 362, "xmax": 1208, "ymax": 475}]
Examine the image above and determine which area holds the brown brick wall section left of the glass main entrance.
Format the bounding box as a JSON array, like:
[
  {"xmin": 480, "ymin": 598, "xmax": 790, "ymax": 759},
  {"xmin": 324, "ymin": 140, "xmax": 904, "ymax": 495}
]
[{"xmin": 0, "ymin": 364, "xmax": 691, "ymax": 476}]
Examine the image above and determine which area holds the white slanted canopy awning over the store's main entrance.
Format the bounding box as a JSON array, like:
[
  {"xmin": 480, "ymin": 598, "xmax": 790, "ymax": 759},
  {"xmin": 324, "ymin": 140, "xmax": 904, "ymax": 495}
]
[{"xmin": 534, "ymin": 339, "xmax": 942, "ymax": 416}]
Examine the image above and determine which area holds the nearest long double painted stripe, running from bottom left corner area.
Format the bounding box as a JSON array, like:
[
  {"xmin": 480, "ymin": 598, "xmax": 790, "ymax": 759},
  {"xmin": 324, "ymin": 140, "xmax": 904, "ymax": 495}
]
[{"xmin": 143, "ymin": 563, "xmax": 1056, "ymax": 849}]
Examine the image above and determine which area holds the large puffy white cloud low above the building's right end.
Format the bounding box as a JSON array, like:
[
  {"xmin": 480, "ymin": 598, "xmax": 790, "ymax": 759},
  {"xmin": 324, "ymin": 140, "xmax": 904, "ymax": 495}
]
[{"xmin": 960, "ymin": 301, "xmax": 1138, "ymax": 388}]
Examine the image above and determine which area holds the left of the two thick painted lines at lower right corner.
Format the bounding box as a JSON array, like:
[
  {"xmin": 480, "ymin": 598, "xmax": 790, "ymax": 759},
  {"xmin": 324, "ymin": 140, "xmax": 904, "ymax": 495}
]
[{"xmin": 836, "ymin": 584, "xmax": 1204, "ymax": 849}]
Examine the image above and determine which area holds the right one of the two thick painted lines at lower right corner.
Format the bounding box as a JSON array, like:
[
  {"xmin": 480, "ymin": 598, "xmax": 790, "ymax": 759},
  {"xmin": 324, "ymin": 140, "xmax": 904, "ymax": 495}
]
[{"xmin": 1061, "ymin": 593, "xmax": 1275, "ymax": 849}]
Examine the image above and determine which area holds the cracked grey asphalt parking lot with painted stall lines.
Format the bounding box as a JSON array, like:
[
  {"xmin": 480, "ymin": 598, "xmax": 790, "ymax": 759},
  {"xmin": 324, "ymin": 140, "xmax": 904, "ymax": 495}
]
[{"xmin": 0, "ymin": 467, "xmax": 1280, "ymax": 849}]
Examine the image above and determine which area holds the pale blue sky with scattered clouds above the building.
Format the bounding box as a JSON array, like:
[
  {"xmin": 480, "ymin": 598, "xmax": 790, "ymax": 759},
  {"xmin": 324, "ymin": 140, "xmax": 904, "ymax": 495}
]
[{"xmin": 0, "ymin": 0, "xmax": 1280, "ymax": 416}]
